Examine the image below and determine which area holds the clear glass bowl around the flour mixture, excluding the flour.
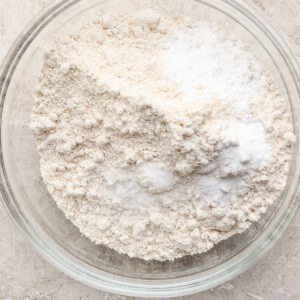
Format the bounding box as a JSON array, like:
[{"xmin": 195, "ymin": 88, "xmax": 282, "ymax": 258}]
[{"xmin": 0, "ymin": 0, "xmax": 300, "ymax": 297}]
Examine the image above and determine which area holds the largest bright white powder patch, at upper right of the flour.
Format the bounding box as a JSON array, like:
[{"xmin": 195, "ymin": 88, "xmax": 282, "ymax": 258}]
[{"xmin": 165, "ymin": 22, "xmax": 268, "ymax": 110}]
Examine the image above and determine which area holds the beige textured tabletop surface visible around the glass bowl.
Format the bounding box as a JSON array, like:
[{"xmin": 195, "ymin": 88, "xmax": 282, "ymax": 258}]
[{"xmin": 0, "ymin": 0, "xmax": 300, "ymax": 300}]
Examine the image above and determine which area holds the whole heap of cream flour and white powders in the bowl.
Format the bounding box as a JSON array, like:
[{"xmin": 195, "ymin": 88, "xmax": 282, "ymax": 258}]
[{"xmin": 31, "ymin": 10, "xmax": 295, "ymax": 261}]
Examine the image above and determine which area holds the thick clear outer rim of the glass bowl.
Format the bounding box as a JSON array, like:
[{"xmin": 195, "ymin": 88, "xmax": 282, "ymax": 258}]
[{"xmin": 0, "ymin": 0, "xmax": 300, "ymax": 298}]
